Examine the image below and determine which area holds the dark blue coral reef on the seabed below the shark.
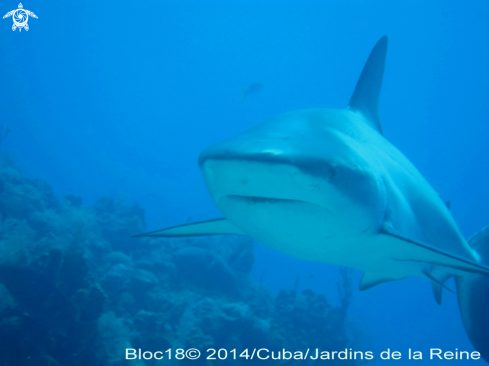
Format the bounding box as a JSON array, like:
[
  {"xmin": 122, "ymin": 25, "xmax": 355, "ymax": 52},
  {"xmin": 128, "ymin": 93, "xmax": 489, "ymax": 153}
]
[{"xmin": 0, "ymin": 159, "xmax": 356, "ymax": 366}]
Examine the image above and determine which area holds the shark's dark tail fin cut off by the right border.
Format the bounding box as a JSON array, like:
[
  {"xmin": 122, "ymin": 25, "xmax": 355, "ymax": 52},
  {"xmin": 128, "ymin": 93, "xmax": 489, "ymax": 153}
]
[{"xmin": 456, "ymin": 226, "xmax": 489, "ymax": 363}]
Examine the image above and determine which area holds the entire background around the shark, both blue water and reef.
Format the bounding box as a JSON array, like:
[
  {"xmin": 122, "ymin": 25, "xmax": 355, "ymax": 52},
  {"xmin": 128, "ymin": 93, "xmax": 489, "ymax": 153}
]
[{"xmin": 0, "ymin": 0, "xmax": 489, "ymax": 365}]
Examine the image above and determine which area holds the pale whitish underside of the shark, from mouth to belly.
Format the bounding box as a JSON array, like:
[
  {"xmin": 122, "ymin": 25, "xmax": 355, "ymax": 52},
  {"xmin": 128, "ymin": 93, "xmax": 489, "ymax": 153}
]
[{"xmin": 218, "ymin": 192, "xmax": 429, "ymax": 280}]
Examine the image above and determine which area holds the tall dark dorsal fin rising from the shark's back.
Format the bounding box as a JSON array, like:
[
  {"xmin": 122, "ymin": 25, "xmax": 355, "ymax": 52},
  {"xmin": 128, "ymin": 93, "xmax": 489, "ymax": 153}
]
[{"xmin": 348, "ymin": 36, "xmax": 388, "ymax": 133}]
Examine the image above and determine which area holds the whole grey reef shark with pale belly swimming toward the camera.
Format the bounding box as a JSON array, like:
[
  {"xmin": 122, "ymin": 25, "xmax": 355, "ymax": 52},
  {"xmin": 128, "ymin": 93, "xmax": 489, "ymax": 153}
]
[{"xmin": 135, "ymin": 37, "xmax": 489, "ymax": 361}]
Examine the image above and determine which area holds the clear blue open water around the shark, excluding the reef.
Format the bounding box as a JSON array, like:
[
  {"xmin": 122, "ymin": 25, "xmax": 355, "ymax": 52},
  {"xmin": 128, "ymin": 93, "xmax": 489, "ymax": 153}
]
[{"xmin": 0, "ymin": 0, "xmax": 489, "ymax": 365}]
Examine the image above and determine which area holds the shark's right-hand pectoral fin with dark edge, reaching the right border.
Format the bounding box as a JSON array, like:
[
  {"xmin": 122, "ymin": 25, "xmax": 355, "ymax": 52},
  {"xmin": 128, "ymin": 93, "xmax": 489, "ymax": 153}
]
[{"xmin": 381, "ymin": 228, "xmax": 489, "ymax": 276}]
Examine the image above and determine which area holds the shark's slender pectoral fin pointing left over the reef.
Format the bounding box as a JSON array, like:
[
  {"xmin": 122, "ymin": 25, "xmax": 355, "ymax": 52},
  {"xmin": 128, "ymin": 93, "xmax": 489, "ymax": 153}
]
[{"xmin": 133, "ymin": 219, "xmax": 246, "ymax": 238}]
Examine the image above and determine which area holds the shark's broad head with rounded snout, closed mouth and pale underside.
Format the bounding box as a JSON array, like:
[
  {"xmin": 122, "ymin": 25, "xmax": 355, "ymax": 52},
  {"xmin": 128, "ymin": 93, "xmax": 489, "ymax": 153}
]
[{"xmin": 199, "ymin": 109, "xmax": 385, "ymax": 256}]
